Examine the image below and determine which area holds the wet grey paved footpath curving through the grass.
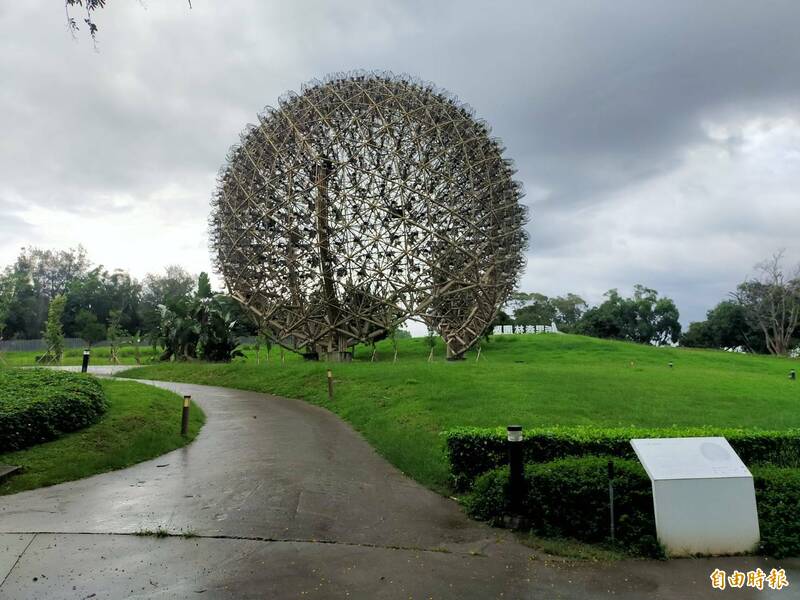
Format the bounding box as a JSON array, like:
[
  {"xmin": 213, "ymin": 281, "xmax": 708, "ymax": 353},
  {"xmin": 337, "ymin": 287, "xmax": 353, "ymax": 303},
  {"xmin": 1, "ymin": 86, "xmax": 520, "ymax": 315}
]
[{"xmin": 0, "ymin": 368, "xmax": 800, "ymax": 600}]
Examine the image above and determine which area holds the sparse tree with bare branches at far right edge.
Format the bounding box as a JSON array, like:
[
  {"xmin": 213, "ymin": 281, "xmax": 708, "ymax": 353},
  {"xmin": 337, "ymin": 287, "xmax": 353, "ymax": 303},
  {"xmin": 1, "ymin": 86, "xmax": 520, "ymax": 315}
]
[{"xmin": 733, "ymin": 251, "xmax": 800, "ymax": 355}]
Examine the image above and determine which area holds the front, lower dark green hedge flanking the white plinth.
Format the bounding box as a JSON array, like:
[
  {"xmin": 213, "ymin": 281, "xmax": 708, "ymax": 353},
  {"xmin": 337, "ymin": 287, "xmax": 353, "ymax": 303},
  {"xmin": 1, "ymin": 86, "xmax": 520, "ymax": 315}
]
[{"xmin": 465, "ymin": 456, "xmax": 800, "ymax": 557}]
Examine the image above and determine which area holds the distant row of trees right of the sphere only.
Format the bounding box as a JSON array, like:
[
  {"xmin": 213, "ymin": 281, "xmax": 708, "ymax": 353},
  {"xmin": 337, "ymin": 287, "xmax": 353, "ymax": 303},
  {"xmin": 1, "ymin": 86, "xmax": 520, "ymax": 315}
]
[{"xmin": 500, "ymin": 252, "xmax": 800, "ymax": 355}]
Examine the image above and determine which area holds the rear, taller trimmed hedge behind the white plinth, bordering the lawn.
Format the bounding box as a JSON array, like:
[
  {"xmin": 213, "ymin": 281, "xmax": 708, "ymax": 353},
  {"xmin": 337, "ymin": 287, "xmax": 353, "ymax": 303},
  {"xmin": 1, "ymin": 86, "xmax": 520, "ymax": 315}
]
[{"xmin": 442, "ymin": 427, "xmax": 800, "ymax": 491}]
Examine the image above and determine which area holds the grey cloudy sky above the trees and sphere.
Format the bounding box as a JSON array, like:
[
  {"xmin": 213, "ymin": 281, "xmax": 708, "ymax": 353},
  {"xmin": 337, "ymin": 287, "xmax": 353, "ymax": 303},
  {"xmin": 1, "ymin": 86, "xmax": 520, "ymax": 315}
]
[{"xmin": 0, "ymin": 0, "xmax": 800, "ymax": 323}]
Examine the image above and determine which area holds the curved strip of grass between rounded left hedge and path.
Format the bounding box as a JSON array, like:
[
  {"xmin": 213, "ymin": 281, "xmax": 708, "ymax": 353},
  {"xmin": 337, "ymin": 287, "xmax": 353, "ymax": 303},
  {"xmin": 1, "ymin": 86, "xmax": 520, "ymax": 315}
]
[{"xmin": 0, "ymin": 380, "xmax": 205, "ymax": 495}]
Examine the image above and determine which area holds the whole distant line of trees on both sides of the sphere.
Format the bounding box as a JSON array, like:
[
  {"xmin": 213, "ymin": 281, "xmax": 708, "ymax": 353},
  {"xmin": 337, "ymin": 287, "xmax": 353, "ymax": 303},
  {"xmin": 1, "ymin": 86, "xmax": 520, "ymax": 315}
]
[{"xmin": 0, "ymin": 246, "xmax": 800, "ymax": 359}]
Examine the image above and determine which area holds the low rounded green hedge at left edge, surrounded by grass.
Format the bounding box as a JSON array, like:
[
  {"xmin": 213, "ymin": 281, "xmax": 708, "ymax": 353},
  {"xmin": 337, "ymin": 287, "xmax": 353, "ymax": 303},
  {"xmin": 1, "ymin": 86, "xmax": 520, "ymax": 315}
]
[{"xmin": 0, "ymin": 369, "xmax": 107, "ymax": 452}]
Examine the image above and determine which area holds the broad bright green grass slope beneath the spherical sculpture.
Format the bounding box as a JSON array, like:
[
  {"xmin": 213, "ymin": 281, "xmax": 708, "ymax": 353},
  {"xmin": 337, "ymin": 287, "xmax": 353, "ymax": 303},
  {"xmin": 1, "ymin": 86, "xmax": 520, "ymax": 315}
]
[{"xmin": 124, "ymin": 335, "xmax": 800, "ymax": 492}]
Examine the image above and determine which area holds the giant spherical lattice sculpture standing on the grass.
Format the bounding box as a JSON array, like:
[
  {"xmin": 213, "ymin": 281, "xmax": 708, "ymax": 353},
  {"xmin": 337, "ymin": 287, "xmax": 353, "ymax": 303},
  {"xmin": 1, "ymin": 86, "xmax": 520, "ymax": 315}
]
[{"xmin": 210, "ymin": 73, "xmax": 526, "ymax": 360}]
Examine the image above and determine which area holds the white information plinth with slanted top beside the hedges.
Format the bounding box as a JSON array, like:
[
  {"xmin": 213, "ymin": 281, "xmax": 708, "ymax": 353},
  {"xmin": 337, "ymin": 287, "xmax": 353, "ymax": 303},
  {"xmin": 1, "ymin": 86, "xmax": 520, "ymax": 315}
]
[{"xmin": 631, "ymin": 437, "xmax": 759, "ymax": 556}]
